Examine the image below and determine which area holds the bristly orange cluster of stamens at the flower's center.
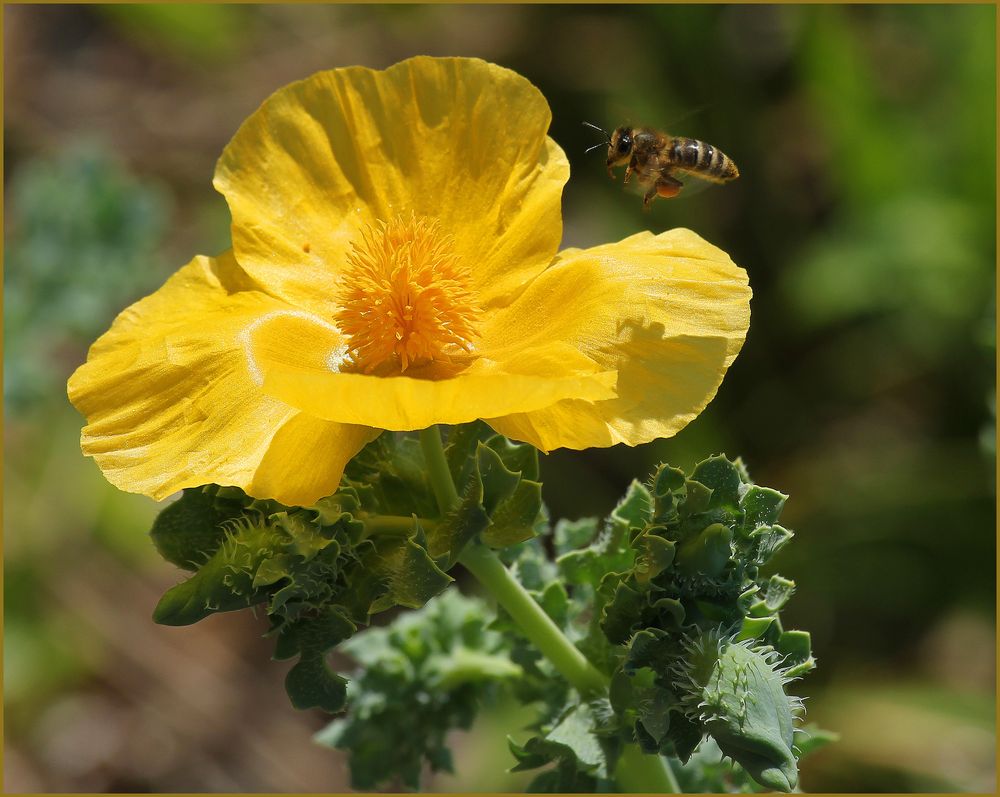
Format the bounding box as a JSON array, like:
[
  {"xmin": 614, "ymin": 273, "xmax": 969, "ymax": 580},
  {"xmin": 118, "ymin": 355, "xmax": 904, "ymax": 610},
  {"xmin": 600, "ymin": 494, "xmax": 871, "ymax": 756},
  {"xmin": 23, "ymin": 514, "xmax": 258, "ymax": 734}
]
[{"xmin": 336, "ymin": 214, "xmax": 480, "ymax": 375}]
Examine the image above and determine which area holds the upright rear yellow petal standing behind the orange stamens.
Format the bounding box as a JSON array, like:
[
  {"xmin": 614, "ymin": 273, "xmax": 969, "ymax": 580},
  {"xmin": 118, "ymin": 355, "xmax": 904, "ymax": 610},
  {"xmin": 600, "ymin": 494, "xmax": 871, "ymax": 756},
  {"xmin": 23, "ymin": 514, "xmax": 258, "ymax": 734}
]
[{"xmin": 214, "ymin": 57, "xmax": 569, "ymax": 310}]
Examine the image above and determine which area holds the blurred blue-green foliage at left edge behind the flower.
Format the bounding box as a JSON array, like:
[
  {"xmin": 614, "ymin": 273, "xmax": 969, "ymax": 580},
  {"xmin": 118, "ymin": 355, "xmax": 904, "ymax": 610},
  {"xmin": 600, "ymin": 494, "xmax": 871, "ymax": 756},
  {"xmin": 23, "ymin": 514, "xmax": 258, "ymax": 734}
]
[{"xmin": 3, "ymin": 145, "xmax": 170, "ymax": 411}]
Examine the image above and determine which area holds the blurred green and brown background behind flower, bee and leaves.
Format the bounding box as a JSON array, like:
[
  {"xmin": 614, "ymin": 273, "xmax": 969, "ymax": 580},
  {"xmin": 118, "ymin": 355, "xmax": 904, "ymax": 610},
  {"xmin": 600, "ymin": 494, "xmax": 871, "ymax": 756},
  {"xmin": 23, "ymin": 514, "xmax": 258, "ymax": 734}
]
[{"xmin": 3, "ymin": 5, "xmax": 996, "ymax": 792}]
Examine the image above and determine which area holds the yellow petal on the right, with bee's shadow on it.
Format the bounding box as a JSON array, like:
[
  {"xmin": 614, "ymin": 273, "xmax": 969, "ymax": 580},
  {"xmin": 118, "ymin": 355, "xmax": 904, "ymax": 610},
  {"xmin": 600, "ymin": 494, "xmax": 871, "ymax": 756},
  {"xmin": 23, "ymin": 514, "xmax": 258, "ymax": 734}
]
[{"xmin": 483, "ymin": 229, "xmax": 751, "ymax": 451}]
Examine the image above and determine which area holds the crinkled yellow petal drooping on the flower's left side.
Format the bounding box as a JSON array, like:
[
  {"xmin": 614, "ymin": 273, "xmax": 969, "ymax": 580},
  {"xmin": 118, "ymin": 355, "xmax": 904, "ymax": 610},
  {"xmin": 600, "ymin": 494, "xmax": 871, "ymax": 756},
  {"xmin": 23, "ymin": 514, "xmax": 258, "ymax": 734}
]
[{"xmin": 69, "ymin": 254, "xmax": 379, "ymax": 504}]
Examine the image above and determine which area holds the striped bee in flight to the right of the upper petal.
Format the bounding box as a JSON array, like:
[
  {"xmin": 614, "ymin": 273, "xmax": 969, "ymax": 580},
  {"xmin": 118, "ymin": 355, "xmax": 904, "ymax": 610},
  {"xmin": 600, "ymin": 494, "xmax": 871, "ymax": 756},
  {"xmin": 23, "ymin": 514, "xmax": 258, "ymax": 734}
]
[{"xmin": 584, "ymin": 122, "xmax": 740, "ymax": 208}]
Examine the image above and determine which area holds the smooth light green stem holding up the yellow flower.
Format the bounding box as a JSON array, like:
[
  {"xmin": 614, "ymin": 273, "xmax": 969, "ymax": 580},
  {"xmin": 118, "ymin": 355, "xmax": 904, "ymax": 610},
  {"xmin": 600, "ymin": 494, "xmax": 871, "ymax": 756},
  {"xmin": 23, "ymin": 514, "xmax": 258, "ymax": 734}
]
[{"xmin": 420, "ymin": 426, "xmax": 680, "ymax": 794}]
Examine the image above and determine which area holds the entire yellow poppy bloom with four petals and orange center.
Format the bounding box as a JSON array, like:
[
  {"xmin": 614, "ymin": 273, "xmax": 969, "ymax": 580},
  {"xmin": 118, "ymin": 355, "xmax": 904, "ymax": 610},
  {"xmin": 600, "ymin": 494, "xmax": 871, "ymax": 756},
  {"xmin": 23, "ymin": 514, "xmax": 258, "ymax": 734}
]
[{"xmin": 69, "ymin": 57, "xmax": 750, "ymax": 504}]
